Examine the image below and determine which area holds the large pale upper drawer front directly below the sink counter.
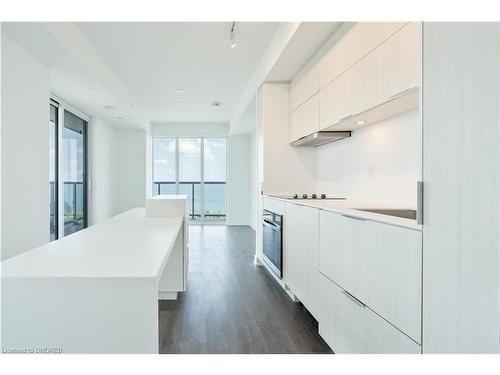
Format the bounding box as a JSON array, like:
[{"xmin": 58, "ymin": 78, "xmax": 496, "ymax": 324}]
[{"xmin": 319, "ymin": 210, "xmax": 422, "ymax": 342}]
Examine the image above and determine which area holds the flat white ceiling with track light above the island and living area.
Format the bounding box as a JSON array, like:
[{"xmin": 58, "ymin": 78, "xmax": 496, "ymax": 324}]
[{"xmin": 2, "ymin": 22, "xmax": 278, "ymax": 127}]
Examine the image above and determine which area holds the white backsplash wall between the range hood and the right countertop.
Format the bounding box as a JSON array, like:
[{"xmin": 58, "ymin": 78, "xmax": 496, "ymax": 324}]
[{"xmin": 316, "ymin": 111, "xmax": 422, "ymax": 208}]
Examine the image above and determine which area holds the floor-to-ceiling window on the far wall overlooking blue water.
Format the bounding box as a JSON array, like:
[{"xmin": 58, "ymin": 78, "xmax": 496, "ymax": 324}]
[{"xmin": 153, "ymin": 137, "xmax": 226, "ymax": 222}]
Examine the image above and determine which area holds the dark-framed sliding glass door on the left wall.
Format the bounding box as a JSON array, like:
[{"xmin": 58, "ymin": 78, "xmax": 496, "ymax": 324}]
[{"xmin": 49, "ymin": 100, "xmax": 88, "ymax": 241}]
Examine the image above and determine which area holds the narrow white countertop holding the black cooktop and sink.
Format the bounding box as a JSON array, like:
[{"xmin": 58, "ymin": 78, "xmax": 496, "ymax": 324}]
[{"xmin": 265, "ymin": 195, "xmax": 422, "ymax": 231}]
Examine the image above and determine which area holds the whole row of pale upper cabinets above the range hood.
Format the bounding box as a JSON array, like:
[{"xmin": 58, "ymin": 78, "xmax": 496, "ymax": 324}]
[{"xmin": 290, "ymin": 22, "xmax": 421, "ymax": 142}]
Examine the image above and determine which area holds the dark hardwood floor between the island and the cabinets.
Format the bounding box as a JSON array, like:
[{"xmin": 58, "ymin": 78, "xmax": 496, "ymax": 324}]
[{"xmin": 159, "ymin": 225, "xmax": 331, "ymax": 353}]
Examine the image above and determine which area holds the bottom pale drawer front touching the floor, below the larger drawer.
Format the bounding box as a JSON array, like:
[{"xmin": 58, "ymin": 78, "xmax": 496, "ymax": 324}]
[{"xmin": 319, "ymin": 276, "xmax": 421, "ymax": 354}]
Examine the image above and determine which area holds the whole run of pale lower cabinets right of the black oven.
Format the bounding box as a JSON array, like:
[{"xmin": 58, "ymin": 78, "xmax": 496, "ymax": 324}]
[{"xmin": 283, "ymin": 203, "xmax": 422, "ymax": 353}]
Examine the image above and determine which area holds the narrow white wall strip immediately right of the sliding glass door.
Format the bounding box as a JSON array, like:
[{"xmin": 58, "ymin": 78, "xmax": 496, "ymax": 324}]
[{"xmin": 89, "ymin": 118, "xmax": 118, "ymax": 225}]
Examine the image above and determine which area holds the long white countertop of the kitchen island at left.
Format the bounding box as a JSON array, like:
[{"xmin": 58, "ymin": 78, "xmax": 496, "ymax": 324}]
[{"xmin": 1, "ymin": 208, "xmax": 182, "ymax": 278}]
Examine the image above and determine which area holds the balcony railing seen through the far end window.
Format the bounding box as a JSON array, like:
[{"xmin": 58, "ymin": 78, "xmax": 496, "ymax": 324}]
[{"xmin": 154, "ymin": 181, "xmax": 226, "ymax": 221}]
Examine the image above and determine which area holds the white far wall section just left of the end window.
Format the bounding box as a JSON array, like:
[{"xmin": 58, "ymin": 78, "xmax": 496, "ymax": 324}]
[{"xmin": 116, "ymin": 129, "xmax": 147, "ymax": 214}]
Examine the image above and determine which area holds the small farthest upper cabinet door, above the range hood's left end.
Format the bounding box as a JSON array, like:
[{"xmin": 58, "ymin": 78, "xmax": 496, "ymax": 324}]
[{"xmin": 290, "ymin": 94, "xmax": 319, "ymax": 142}]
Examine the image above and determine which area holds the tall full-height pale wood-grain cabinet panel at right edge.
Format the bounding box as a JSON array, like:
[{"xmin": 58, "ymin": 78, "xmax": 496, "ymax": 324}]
[{"xmin": 423, "ymin": 22, "xmax": 500, "ymax": 353}]
